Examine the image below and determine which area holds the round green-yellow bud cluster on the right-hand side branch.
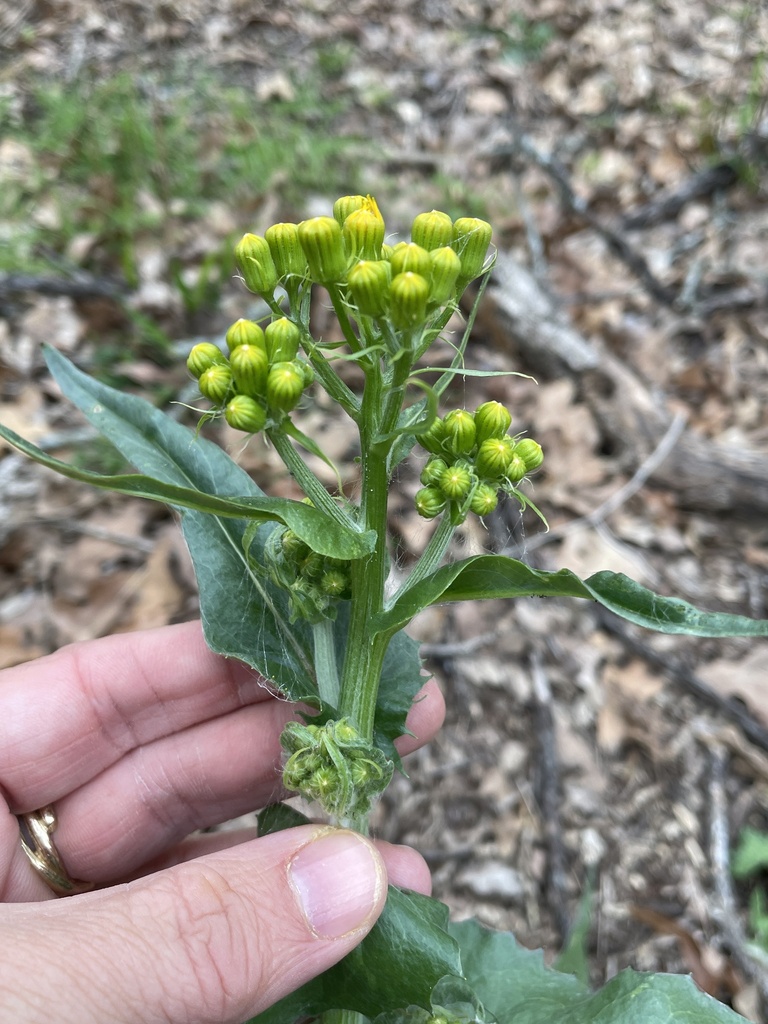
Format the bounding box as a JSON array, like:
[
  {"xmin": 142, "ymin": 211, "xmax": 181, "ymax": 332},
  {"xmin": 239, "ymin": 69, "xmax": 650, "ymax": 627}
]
[{"xmin": 415, "ymin": 401, "xmax": 544, "ymax": 524}]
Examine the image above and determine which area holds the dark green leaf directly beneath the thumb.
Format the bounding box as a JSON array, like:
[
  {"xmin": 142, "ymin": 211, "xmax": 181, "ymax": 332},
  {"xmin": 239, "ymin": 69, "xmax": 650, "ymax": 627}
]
[{"xmin": 249, "ymin": 886, "xmax": 461, "ymax": 1024}]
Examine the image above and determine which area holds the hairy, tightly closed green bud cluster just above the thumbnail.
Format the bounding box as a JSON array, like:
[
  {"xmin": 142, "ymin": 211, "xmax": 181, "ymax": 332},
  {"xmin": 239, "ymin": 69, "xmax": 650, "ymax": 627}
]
[{"xmin": 280, "ymin": 718, "xmax": 394, "ymax": 820}]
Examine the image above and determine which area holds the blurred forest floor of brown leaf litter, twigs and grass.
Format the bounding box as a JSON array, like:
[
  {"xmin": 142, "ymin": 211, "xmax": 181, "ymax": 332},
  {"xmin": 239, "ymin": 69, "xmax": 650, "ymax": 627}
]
[{"xmin": 0, "ymin": 0, "xmax": 768, "ymax": 1021}]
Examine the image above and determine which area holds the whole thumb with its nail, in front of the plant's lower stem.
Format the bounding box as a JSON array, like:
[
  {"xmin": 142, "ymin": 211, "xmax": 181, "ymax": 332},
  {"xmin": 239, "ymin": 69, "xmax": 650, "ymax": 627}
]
[{"xmin": 0, "ymin": 825, "xmax": 387, "ymax": 1024}]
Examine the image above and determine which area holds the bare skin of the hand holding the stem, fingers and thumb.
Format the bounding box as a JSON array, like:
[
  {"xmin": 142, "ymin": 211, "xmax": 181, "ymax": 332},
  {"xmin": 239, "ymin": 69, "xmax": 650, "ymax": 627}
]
[{"xmin": 0, "ymin": 623, "xmax": 444, "ymax": 1024}]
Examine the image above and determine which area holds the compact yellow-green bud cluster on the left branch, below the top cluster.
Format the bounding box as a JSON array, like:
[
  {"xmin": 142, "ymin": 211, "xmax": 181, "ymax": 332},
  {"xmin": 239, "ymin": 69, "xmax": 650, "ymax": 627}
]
[{"xmin": 186, "ymin": 316, "xmax": 314, "ymax": 434}]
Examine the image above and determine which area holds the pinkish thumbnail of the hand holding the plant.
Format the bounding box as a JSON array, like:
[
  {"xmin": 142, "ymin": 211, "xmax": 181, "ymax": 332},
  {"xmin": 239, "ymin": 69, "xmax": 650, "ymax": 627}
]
[{"xmin": 288, "ymin": 831, "xmax": 386, "ymax": 939}]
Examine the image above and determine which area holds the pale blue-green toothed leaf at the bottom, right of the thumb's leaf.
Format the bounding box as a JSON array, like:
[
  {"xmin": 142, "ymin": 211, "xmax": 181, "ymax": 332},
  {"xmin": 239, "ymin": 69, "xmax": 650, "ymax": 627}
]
[{"xmin": 450, "ymin": 921, "xmax": 743, "ymax": 1024}]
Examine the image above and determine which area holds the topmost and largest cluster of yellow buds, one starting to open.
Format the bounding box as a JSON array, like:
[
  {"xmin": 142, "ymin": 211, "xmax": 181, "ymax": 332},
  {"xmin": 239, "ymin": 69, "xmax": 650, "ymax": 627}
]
[{"xmin": 234, "ymin": 196, "xmax": 492, "ymax": 344}]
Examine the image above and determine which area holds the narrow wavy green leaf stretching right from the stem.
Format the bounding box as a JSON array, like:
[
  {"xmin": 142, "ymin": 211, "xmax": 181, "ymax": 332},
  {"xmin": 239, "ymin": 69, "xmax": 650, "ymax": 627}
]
[{"xmin": 373, "ymin": 555, "xmax": 768, "ymax": 637}]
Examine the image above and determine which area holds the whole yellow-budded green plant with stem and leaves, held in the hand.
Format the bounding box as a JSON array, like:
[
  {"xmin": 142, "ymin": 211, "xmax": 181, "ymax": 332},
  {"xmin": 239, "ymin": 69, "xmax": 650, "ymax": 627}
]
[{"xmin": 0, "ymin": 196, "xmax": 768, "ymax": 1024}]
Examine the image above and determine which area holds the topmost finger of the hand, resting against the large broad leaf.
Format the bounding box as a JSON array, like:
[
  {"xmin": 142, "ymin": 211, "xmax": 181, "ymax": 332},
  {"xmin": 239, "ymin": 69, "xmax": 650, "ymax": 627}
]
[{"xmin": 0, "ymin": 623, "xmax": 273, "ymax": 810}]
